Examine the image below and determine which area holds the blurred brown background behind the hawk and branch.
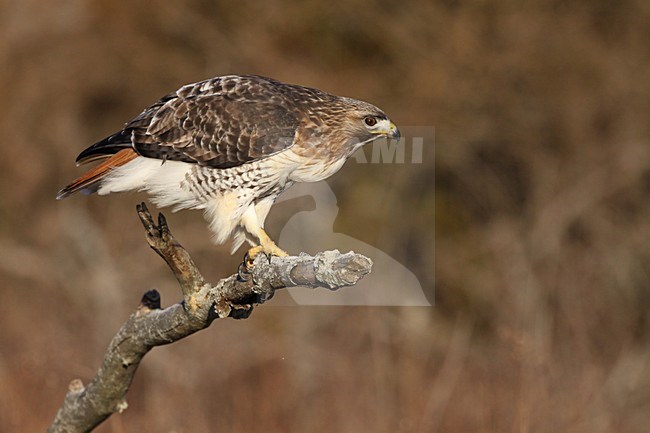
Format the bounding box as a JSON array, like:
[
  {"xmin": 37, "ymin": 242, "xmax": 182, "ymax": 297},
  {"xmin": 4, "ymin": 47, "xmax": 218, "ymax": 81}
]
[{"xmin": 0, "ymin": 0, "xmax": 650, "ymax": 432}]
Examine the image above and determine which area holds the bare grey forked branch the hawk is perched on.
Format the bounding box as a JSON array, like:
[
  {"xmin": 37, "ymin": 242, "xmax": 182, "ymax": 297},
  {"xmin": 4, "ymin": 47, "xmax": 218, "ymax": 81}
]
[{"xmin": 47, "ymin": 203, "xmax": 372, "ymax": 433}]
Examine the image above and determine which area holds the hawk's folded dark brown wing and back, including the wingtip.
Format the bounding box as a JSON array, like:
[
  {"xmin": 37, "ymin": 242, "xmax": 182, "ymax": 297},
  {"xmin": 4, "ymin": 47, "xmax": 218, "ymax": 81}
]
[{"xmin": 77, "ymin": 76, "xmax": 300, "ymax": 168}]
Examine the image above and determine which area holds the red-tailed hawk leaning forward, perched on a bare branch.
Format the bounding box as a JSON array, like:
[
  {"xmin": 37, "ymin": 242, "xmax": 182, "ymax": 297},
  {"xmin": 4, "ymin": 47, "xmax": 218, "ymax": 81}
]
[{"xmin": 57, "ymin": 75, "xmax": 399, "ymax": 259}]
